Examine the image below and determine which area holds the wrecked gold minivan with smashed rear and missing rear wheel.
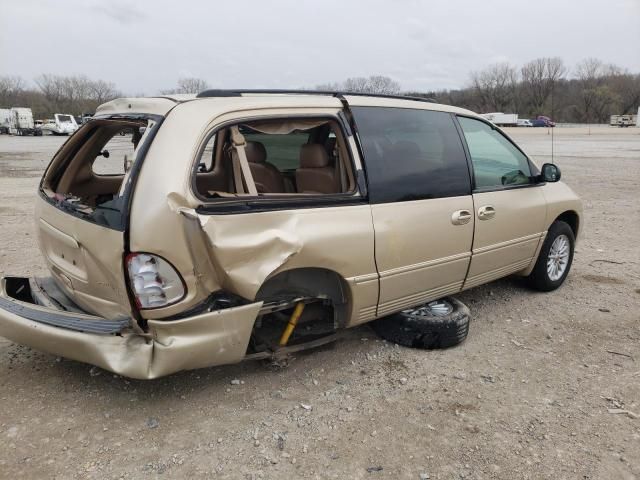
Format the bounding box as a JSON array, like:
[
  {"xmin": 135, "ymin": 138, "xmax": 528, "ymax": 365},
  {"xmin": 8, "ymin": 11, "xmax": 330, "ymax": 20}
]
[{"xmin": 0, "ymin": 90, "xmax": 582, "ymax": 379}]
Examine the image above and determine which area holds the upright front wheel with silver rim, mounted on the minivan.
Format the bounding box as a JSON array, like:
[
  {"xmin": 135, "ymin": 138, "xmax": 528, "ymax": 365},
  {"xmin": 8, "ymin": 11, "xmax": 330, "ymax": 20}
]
[{"xmin": 528, "ymin": 220, "xmax": 576, "ymax": 292}]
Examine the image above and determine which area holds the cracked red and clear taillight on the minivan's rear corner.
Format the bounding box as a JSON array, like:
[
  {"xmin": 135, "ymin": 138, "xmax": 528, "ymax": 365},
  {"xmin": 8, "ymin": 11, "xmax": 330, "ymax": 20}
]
[{"xmin": 127, "ymin": 253, "xmax": 185, "ymax": 308}]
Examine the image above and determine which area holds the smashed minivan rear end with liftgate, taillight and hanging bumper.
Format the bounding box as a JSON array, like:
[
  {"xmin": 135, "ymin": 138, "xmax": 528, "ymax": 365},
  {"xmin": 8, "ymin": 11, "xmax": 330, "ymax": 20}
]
[{"xmin": 0, "ymin": 99, "xmax": 272, "ymax": 378}]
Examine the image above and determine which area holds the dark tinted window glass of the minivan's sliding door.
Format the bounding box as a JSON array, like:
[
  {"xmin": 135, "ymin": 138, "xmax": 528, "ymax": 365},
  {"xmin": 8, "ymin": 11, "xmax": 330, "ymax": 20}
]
[{"xmin": 352, "ymin": 107, "xmax": 471, "ymax": 203}]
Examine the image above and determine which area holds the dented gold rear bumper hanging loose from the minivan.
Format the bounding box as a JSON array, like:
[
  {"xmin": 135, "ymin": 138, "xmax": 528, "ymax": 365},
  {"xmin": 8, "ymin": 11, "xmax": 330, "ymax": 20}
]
[{"xmin": 0, "ymin": 278, "xmax": 262, "ymax": 379}]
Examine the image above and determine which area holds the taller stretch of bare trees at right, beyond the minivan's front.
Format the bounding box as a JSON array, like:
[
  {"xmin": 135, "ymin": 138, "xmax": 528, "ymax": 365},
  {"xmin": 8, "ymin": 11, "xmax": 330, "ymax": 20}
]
[{"xmin": 411, "ymin": 57, "xmax": 640, "ymax": 123}]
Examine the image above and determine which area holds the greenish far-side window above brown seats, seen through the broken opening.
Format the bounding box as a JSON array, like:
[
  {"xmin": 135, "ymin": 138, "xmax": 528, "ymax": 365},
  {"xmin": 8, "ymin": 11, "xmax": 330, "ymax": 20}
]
[{"xmin": 240, "ymin": 127, "xmax": 309, "ymax": 171}]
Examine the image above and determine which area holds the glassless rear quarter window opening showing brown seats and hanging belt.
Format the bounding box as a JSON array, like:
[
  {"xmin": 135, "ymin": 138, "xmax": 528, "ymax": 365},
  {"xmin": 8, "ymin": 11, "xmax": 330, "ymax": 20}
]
[{"xmin": 195, "ymin": 118, "xmax": 356, "ymax": 199}]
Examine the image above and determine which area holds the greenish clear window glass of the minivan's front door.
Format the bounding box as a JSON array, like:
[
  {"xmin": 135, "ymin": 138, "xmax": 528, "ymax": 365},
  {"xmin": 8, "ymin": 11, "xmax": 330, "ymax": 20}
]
[{"xmin": 458, "ymin": 117, "xmax": 531, "ymax": 189}]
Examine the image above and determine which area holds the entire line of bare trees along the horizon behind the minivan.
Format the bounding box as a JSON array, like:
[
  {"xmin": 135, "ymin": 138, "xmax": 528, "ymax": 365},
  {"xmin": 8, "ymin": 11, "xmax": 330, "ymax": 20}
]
[{"xmin": 0, "ymin": 57, "xmax": 640, "ymax": 123}]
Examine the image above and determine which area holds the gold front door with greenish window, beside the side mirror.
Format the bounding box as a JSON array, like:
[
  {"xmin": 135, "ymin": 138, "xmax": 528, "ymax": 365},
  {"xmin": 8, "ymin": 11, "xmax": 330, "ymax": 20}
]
[{"xmin": 458, "ymin": 117, "xmax": 546, "ymax": 288}]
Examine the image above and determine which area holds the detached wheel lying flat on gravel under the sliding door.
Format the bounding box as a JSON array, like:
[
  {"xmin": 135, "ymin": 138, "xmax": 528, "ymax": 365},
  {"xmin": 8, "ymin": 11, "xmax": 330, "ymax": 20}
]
[{"xmin": 371, "ymin": 297, "xmax": 470, "ymax": 350}]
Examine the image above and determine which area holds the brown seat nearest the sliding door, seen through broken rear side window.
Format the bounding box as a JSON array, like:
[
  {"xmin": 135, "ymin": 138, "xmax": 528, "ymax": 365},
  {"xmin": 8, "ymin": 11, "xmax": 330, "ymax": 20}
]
[{"xmin": 296, "ymin": 143, "xmax": 342, "ymax": 193}]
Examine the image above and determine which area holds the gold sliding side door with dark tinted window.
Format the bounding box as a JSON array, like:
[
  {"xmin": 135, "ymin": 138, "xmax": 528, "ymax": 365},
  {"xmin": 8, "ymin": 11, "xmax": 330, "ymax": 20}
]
[{"xmin": 348, "ymin": 103, "xmax": 474, "ymax": 317}]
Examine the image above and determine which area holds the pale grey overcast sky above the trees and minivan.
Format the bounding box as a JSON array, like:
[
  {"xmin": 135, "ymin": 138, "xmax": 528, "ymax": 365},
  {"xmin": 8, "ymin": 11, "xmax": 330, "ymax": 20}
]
[{"xmin": 0, "ymin": 0, "xmax": 640, "ymax": 94}]
